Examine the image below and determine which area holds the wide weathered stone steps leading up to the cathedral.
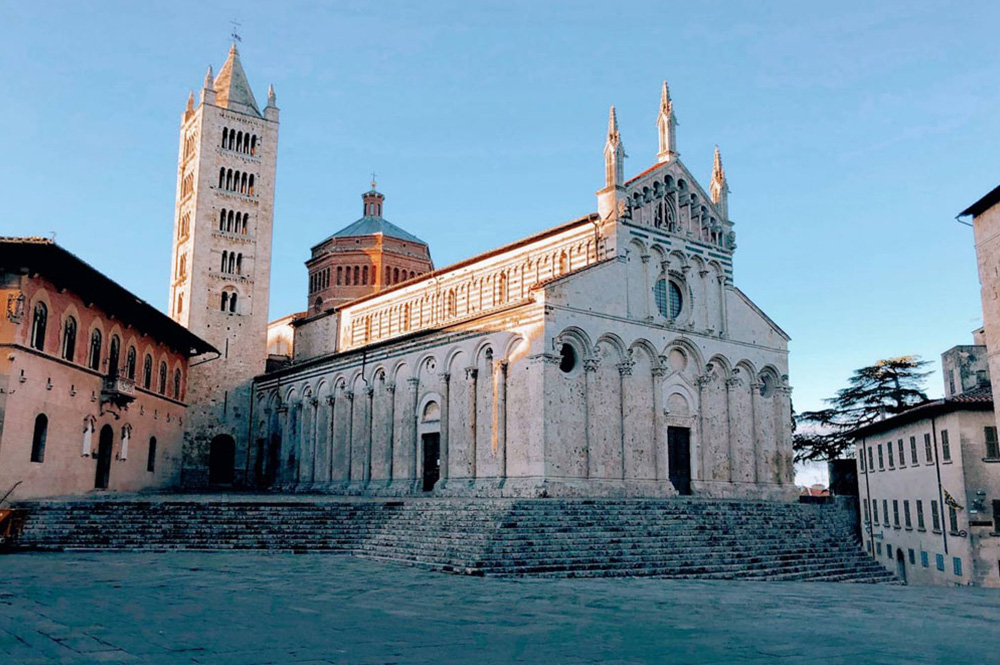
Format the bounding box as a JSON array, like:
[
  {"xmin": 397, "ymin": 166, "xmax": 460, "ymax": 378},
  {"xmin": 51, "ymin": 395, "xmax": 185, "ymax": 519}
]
[{"xmin": 9, "ymin": 495, "xmax": 894, "ymax": 582}]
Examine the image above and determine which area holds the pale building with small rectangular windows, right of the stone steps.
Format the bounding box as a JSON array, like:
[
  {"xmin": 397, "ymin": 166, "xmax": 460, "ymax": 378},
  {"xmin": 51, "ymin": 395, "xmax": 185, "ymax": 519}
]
[{"xmin": 854, "ymin": 345, "xmax": 1000, "ymax": 586}]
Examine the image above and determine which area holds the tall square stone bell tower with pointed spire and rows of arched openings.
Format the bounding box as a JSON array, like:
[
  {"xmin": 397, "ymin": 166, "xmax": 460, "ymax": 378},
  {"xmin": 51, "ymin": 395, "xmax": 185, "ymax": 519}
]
[{"xmin": 169, "ymin": 43, "xmax": 278, "ymax": 487}]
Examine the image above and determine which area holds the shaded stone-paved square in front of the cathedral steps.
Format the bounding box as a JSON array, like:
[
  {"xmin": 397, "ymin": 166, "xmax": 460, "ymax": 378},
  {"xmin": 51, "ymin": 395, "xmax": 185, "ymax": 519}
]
[{"xmin": 0, "ymin": 552, "xmax": 1000, "ymax": 665}]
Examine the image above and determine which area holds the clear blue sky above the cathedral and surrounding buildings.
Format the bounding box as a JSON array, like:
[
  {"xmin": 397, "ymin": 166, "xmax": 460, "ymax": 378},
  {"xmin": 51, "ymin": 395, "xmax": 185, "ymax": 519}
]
[{"xmin": 0, "ymin": 0, "xmax": 1000, "ymax": 411}]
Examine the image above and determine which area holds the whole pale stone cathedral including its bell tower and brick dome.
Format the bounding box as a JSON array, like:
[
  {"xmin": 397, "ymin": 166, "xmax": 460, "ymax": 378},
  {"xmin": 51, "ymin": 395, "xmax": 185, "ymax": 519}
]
[{"xmin": 170, "ymin": 46, "xmax": 796, "ymax": 499}]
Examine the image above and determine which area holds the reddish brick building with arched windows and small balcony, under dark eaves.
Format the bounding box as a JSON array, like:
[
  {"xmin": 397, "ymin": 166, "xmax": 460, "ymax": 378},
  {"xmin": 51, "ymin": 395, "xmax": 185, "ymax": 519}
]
[{"xmin": 0, "ymin": 238, "xmax": 215, "ymax": 499}]
